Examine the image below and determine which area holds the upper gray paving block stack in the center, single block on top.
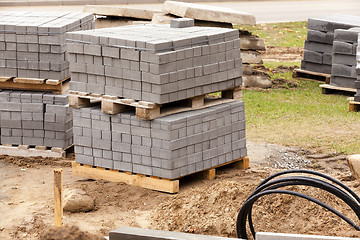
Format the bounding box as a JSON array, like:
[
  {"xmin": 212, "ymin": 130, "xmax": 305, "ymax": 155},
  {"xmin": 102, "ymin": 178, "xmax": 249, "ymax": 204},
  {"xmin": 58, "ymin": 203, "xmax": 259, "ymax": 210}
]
[{"xmin": 67, "ymin": 24, "xmax": 242, "ymax": 104}]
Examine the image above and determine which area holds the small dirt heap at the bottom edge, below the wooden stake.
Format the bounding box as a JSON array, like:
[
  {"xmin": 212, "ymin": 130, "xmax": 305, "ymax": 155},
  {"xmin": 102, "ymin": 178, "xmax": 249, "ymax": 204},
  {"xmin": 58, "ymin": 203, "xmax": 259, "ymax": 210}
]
[{"xmin": 40, "ymin": 226, "xmax": 104, "ymax": 240}]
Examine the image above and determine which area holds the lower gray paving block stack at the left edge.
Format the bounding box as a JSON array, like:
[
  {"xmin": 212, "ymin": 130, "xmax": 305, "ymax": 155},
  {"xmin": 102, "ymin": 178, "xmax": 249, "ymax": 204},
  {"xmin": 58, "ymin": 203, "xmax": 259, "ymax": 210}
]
[{"xmin": 0, "ymin": 90, "xmax": 73, "ymax": 148}]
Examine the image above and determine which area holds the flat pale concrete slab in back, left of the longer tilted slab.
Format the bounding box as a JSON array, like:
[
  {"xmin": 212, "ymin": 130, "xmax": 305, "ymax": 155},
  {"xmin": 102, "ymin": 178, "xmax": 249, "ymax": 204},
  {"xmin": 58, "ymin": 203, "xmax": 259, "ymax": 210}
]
[{"xmin": 84, "ymin": 5, "xmax": 158, "ymax": 20}]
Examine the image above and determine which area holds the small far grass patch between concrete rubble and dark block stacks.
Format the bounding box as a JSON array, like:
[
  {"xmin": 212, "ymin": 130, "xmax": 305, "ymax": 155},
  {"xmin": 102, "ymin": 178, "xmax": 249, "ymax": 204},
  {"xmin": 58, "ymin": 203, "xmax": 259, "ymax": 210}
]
[{"xmin": 235, "ymin": 22, "xmax": 307, "ymax": 47}]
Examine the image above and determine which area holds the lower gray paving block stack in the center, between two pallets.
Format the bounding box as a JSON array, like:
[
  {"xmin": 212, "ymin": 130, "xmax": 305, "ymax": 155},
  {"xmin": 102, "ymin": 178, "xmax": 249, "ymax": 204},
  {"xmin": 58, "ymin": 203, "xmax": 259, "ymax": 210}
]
[{"xmin": 73, "ymin": 101, "xmax": 247, "ymax": 179}]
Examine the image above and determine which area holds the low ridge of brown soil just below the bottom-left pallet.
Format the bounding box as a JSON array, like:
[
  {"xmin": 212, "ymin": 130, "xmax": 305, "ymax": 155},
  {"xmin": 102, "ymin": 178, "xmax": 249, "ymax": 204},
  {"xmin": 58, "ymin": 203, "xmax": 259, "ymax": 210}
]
[{"xmin": 0, "ymin": 155, "xmax": 71, "ymax": 168}]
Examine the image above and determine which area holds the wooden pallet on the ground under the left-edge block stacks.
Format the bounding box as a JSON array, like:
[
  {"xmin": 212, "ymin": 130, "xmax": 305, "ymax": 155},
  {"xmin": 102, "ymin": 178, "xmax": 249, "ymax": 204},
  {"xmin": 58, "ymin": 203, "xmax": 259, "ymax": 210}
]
[{"xmin": 0, "ymin": 144, "xmax": 72, "ymax": 158}]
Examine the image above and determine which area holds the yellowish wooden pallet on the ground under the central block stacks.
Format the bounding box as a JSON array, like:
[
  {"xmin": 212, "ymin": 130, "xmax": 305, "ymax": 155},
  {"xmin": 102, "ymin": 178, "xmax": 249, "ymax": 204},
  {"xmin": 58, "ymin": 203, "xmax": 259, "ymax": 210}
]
[{"xmin": 72, "ymin": 157, "xmax": 249, "ymax": 193}]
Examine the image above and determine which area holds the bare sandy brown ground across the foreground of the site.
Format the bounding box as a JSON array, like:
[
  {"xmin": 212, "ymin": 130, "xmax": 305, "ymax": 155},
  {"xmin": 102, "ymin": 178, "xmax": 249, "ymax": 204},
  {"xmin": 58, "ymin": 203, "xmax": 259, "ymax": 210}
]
[{"xmin": 0, "ymin": 142, "xmax": 360, "ymax": 239}]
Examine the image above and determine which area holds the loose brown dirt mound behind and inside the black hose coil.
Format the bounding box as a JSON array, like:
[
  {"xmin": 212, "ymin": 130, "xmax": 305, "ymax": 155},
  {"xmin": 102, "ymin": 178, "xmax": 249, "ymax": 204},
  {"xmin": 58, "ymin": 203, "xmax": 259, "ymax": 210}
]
[{"xmin": 153, "ymin": 177, "xmax": 360, "ymax": 237}]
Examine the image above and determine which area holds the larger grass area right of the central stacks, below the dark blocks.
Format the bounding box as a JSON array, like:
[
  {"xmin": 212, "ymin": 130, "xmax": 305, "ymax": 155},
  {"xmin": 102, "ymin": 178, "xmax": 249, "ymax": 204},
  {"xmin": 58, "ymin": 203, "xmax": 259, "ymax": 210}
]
[{"xmin": 244, "ymin": 62, "xmax": 360, "ymax": 154}]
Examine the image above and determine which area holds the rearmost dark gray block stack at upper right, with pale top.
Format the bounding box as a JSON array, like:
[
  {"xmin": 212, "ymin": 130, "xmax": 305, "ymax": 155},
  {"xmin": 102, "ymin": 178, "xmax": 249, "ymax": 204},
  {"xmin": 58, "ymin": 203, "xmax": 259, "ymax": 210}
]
[{"xmin": 301, "ymin": 14, "xmax": 360, "ymax": 74}]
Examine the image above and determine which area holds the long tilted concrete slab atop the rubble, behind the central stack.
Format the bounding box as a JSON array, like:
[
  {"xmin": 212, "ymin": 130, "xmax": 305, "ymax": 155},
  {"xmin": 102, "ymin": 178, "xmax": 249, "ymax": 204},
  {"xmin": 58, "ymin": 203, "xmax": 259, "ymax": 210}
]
[{"xmin": 163, "ymin": 1, "xmax": 256, "ymax": 25}]
